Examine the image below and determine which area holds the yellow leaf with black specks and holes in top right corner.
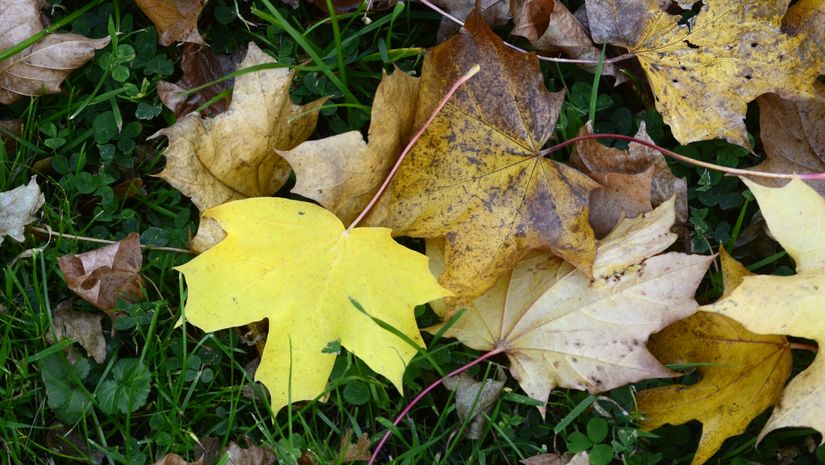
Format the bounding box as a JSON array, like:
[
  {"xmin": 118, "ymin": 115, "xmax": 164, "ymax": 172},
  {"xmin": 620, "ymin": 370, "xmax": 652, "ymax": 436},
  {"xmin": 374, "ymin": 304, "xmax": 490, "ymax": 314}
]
[{"xmin": 587, "ymin": 0, "xmax": 825, "ymax": 147}]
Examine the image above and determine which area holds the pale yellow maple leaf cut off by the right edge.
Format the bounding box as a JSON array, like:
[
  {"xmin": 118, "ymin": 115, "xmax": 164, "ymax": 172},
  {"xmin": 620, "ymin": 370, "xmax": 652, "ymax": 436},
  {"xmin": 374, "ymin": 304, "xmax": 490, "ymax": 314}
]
[{"xmin": 701, "ymin": 179, "xmax": 825, "ymax": 439}]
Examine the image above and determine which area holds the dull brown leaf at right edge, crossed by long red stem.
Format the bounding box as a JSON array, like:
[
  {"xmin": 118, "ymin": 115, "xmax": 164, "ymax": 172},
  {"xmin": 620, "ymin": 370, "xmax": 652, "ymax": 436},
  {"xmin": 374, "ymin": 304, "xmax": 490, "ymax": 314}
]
[{"xmin": 751, "ymin": 94, "xmax": 825, "ymax": 196}]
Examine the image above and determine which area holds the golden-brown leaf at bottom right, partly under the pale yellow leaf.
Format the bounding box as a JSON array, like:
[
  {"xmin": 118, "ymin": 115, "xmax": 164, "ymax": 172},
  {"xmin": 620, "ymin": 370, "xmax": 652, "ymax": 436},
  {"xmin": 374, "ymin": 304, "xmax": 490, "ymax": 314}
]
[{"xmin": 636, "ymin": 249, "xmax": 792, "ymax": 465}]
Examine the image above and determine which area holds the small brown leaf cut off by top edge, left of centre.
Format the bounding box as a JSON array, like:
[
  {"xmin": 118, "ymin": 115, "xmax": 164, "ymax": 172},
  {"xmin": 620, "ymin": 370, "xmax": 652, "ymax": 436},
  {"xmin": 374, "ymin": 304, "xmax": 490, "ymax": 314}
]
[{"xmin": 136, "ymin": 0, "xmax": 206, "ymax": 45}]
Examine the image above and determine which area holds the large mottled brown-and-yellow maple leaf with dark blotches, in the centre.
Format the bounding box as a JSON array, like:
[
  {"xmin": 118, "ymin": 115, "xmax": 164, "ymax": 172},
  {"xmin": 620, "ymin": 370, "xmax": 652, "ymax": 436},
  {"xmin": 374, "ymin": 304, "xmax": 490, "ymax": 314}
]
[{"xmin": 368, "ymin": 12, "xmax": 597, "ymax": 299}]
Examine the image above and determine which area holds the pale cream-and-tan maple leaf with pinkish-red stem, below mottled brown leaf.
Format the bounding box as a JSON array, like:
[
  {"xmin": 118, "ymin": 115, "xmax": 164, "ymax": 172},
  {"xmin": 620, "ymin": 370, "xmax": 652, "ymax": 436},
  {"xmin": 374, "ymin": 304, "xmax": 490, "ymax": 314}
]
[{"xmin": 427, "ymin": 200, "xmax": 710, "ymax": 408}]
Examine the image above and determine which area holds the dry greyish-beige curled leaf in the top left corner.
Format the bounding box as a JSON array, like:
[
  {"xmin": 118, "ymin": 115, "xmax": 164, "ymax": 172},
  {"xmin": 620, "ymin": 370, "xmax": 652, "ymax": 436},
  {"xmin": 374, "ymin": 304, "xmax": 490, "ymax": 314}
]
[{"xmin": 0, "ymin": 0, "xmax": 109, "ymax": 105}]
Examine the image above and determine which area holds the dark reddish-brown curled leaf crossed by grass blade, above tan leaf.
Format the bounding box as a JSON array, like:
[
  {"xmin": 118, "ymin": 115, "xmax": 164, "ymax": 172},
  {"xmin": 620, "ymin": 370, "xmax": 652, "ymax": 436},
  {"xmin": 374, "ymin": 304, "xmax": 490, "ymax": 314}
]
[{"xmin": 158, "ymin": 43, "xmax": 239, "ymax": 119}]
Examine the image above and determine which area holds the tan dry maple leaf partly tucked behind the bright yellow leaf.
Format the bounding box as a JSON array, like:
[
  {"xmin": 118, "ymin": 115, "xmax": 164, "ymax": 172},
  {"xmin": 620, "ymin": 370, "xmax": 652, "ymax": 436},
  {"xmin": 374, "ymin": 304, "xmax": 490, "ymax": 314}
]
[{"xmin": 152, "ymin": 42, "xmax": 325, "ymax": 252}]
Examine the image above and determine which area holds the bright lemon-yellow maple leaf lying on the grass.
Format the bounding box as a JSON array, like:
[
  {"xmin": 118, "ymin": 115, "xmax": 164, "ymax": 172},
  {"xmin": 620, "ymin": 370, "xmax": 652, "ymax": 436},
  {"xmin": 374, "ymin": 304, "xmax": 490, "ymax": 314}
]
[{"xmin": 177, "ymin": 197, "xmax": 449, "ymax": 412}]
